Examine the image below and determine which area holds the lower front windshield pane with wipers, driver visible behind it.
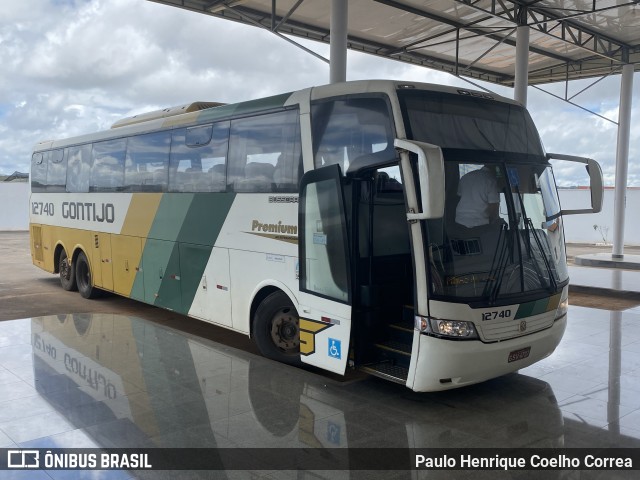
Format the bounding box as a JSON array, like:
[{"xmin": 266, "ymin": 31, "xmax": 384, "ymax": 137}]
[{"xmin": 427, "ymin": 162, "xmax": 568, "ymax": 304}]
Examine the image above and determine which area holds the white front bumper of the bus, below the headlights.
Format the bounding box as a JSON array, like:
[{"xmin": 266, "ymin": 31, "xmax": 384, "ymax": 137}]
[{"xmin": 407, "ymin": 315, "xmax": 567, "ymax": 392}]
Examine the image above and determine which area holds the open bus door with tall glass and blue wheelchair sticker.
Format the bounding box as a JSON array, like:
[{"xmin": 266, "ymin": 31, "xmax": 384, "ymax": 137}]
[{"xmin": 298, "ymin": 165, "xmax": 352, "ymax": 374}]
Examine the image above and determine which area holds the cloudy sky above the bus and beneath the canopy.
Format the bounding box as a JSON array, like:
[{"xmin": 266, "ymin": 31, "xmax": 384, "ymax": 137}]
[{"xmin": 0, "ymin": 0, "xmax": 640, "ymax": 186}]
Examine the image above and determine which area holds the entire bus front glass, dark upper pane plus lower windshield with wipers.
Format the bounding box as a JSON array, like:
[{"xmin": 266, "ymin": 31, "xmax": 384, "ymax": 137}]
[{"xmin": 402, "ymin": 92, "xmax": 568, "ymax": 305}]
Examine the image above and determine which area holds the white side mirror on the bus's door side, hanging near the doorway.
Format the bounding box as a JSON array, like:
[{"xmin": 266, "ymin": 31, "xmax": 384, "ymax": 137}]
[{"xmin": 393, "ymin": 138, "xmax": 444, "ymax": 220}]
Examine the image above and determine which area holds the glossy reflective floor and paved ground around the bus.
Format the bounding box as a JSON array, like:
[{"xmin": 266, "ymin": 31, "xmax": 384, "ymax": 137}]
[{"xmin": 0, "ymin": 233, "xmax": 640, "ymax": 480}]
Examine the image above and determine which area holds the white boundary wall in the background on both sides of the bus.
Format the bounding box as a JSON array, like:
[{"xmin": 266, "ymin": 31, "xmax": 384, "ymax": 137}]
[{"xmin": 0, "ymin": 182, "xmax": 640, "ymax": 245}]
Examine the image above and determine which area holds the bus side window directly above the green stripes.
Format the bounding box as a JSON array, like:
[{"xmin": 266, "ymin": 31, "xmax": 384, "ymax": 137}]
[{"xmin": 169, "ymin": 121, "xmax": 229, "ymax": 192}]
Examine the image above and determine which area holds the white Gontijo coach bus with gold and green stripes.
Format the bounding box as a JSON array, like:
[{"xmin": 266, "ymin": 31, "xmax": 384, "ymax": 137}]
[{"xmin": 30, "ymin": 81, "xmax": 602, "ymax": 391}]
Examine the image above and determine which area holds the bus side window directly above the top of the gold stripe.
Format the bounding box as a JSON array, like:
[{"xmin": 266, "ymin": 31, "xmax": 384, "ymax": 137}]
[{"xmin": 124, "ymin": 131, "xmax": 171, "ymax": 192}]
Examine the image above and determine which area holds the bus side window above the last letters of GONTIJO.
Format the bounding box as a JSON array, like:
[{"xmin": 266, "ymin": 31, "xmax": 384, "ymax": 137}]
[{"xmin": 89, "ymin": 138, "xmax": 127, "ymax": 192}]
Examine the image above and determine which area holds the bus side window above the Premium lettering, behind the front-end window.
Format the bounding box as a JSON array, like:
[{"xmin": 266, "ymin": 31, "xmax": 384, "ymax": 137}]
[{"xmin": 229, "ymin": 110, "xmax": 301, "ymax": 192}]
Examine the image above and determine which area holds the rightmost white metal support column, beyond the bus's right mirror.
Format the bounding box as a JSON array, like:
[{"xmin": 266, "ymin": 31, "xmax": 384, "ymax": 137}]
[{"xmin": 611, "ymin": 65, "xmax": 633, "ymax": 258}]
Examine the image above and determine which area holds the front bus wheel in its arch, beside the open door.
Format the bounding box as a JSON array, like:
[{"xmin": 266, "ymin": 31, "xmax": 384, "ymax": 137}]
[{"xmin": 253, "ymin": 291, "xmax": 302, "ymax": 365}]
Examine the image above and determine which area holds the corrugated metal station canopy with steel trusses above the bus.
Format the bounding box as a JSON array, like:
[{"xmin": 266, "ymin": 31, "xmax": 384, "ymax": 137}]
[{"xmin": 151, "ymin": 0, "xmax": 640, "ymax": 86}]
